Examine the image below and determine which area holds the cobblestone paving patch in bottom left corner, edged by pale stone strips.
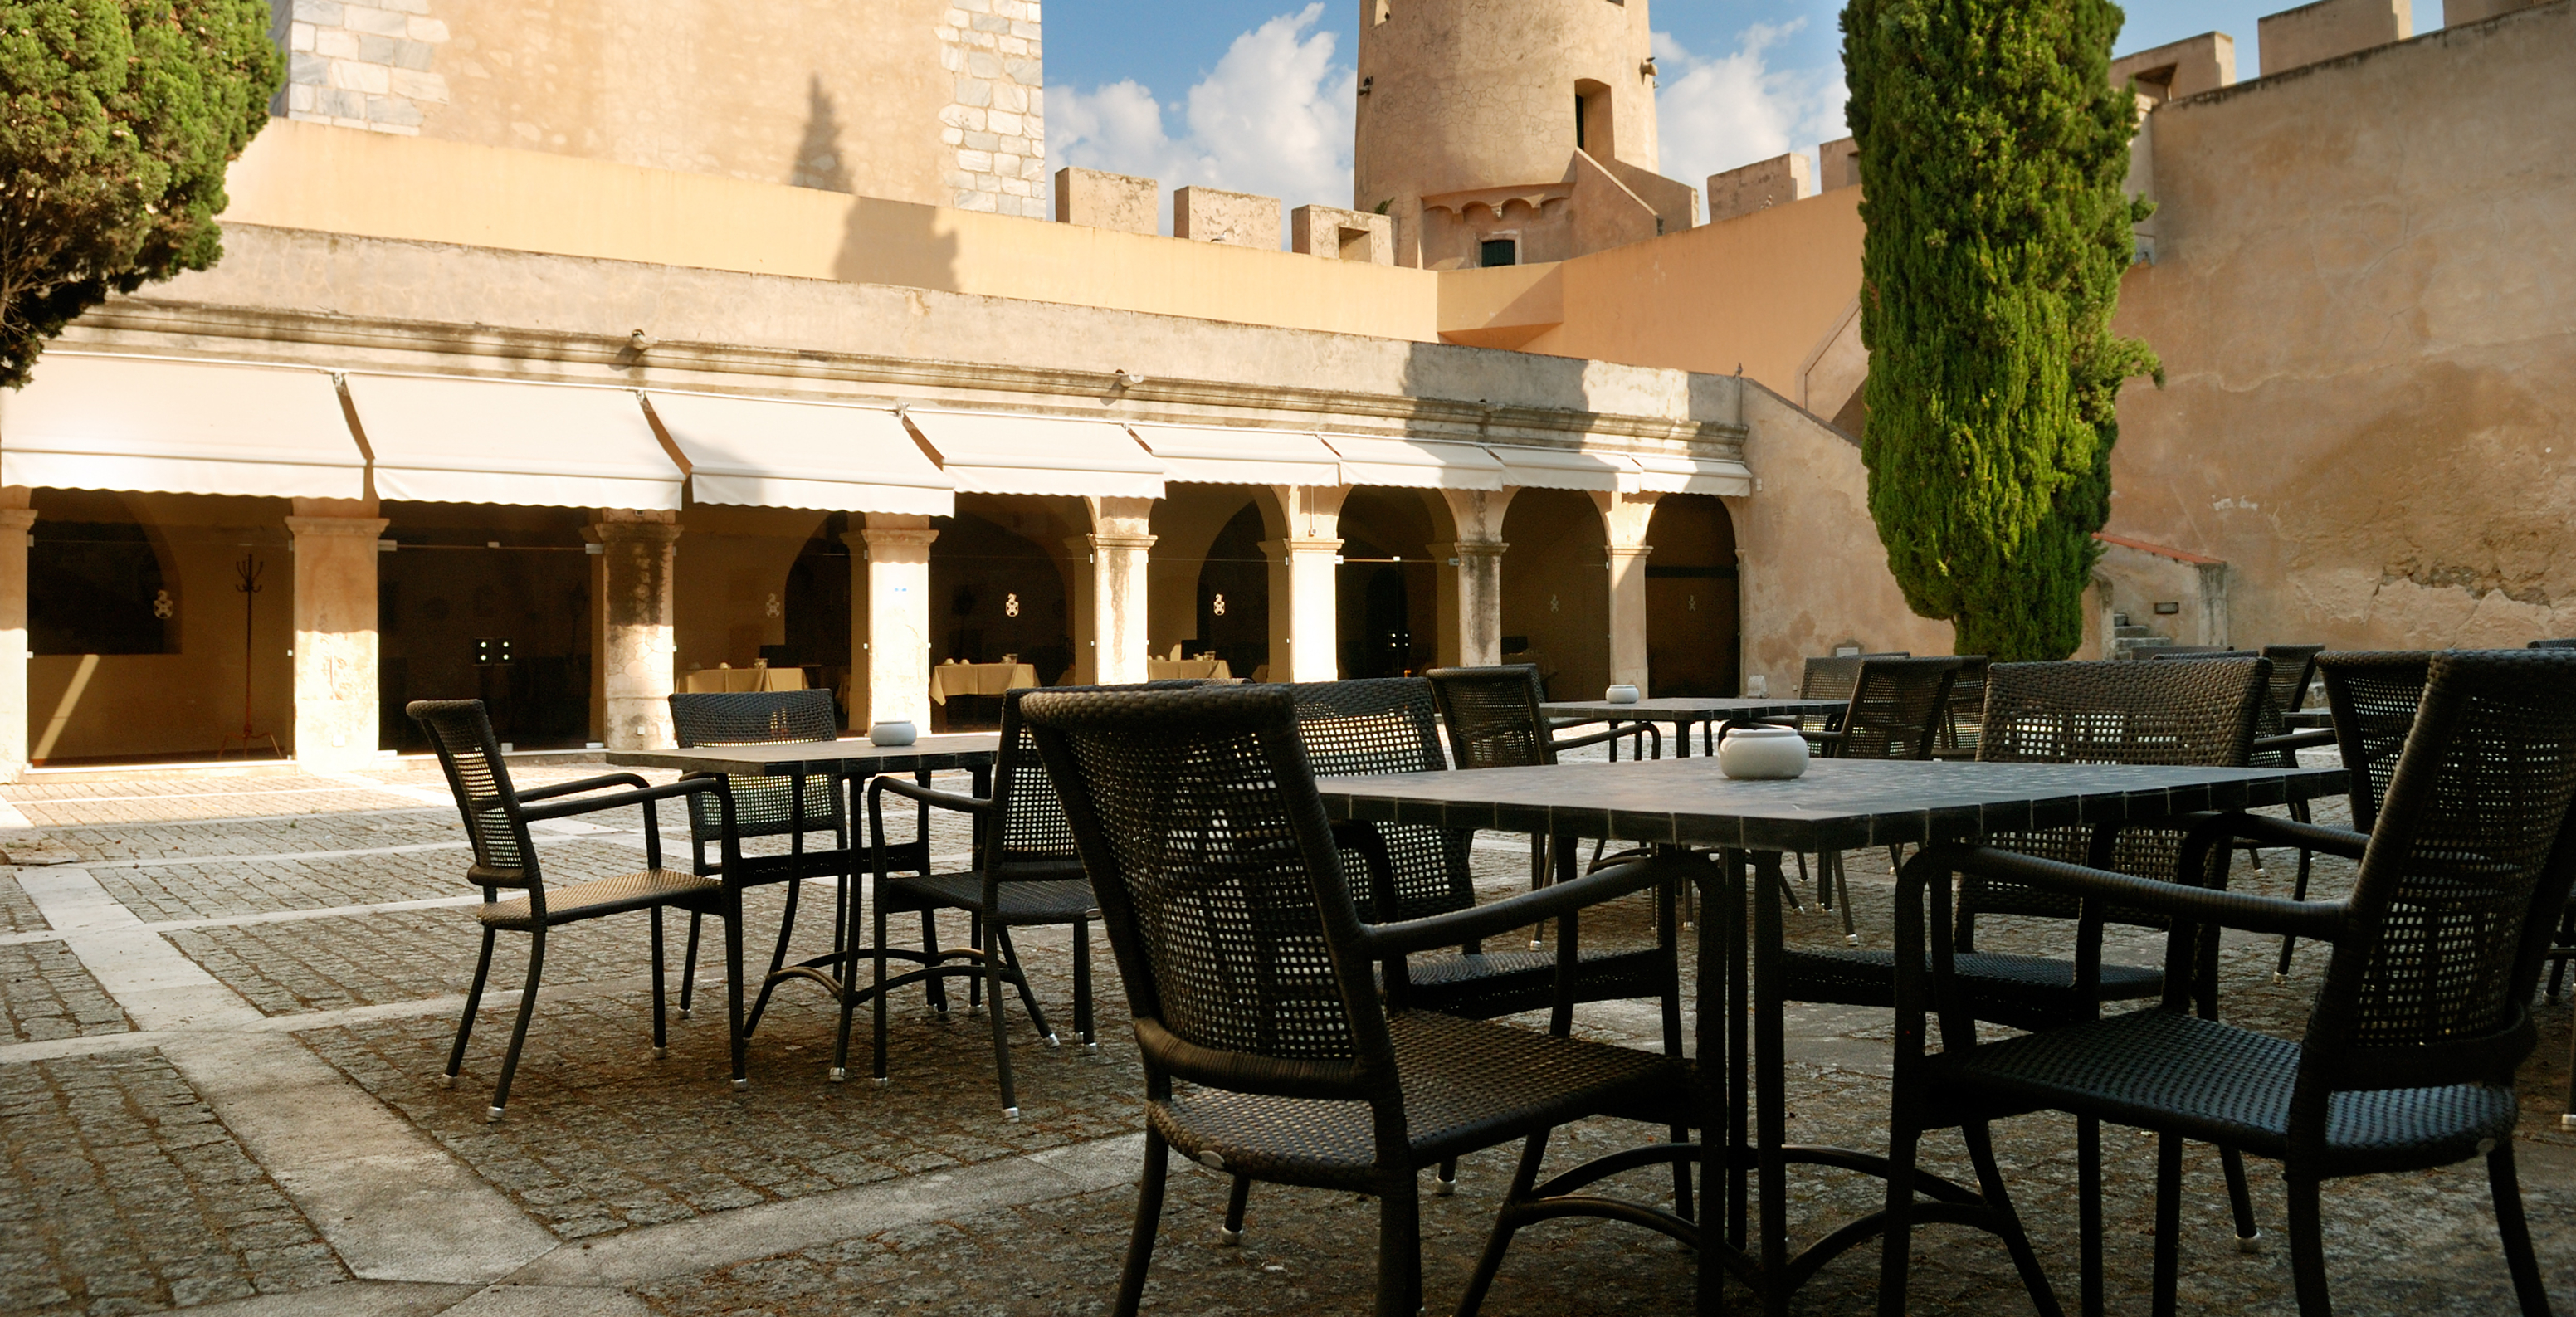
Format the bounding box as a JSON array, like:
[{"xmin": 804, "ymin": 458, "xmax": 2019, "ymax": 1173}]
[{"xmin": 0, "ymin": 1054, "xmax": 348, "ymax": 1317}]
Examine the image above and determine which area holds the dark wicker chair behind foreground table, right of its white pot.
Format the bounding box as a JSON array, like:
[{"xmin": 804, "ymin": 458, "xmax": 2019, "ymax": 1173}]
[{"xmin": 1780, "ymin": 657, "xmax": 2272, "ymax": 1267}]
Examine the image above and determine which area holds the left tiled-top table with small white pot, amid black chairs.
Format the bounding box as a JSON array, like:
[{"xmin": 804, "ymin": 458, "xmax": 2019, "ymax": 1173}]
[{"xmin": 605, "ymin": 732, "xmax": 999, "ymax": 1082}]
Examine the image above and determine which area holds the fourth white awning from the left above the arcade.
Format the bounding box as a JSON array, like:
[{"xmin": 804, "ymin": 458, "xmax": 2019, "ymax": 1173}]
[{"xmin": 905, "ymin": 407, "xmax": 1164, "ymax": 497}]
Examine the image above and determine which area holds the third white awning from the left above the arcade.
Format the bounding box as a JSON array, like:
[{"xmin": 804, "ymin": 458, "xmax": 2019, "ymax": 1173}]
[{"xmin": 644, "ymin": 389, "xmax": 959, "ymax": 515}]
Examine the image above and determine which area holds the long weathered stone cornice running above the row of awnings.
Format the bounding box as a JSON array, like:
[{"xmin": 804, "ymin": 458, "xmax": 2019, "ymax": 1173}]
[{"xmin": 61, "ymin": 296, "xmax": 1744, "ymax": 459}]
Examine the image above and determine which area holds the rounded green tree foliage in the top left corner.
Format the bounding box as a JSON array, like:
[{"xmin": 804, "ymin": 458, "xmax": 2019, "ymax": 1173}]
[{"xmin": 0, "ymin": 0, "xmax": 286, "ymax": 387}]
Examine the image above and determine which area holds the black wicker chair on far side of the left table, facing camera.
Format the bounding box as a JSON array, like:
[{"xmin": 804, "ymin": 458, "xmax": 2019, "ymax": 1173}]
[{"xmin": 670, "ymin": 690, "xmax": 858, "ymax": 1033}]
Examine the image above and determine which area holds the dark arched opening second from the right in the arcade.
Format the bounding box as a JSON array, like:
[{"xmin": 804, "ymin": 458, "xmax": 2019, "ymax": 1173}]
[{"xmin": 1502, "ymin": 490, "xmax": 1610, "ymax": 699}]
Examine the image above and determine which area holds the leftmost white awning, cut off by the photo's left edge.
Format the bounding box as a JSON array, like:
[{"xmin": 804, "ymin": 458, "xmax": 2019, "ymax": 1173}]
[{"xmin": 0, "ymin": 350, "xmax": 366, "ymax": 497}]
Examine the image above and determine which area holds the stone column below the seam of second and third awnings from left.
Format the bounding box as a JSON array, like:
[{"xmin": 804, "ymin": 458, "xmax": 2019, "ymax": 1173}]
[{"xmin": 593, "ymin": 508, "xmax": 680, "ymax": 750}]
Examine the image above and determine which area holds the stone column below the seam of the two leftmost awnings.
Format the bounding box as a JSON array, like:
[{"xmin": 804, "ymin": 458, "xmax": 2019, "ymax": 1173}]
[{"xmin": 286, "ymin": 497, "xmax": 387, "ymax": 771}]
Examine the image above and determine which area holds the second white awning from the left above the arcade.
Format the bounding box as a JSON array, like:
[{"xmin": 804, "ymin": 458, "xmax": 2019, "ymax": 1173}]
[{"xmin": 348, "ymin": 373, "xmax": 680, "ymax": 510}]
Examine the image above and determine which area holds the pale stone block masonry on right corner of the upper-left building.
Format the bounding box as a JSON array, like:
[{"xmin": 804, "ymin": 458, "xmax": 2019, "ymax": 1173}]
[{"xmin": 938, "ymin": 0, "xmax": 1048, "ymax": 219}]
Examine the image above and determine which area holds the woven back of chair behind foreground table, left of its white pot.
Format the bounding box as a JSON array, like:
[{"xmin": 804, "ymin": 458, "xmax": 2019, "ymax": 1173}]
[{"xmin": 1288, "ymin": 678, "xmax": 1476, "ymax": 923}]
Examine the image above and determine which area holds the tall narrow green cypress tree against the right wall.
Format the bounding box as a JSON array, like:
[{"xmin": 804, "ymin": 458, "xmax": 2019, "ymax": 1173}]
[{"xmin": 1842, "ymin": 0, "xmax": 2161, "ymax": 660}]
